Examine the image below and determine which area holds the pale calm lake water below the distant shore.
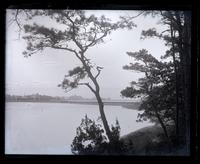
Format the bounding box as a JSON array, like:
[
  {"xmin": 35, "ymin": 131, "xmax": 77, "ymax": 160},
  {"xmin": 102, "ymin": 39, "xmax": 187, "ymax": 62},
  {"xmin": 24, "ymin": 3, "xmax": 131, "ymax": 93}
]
[{"xmin": 5, "ymin": 102, "xmax": 151, "ymax": 154}]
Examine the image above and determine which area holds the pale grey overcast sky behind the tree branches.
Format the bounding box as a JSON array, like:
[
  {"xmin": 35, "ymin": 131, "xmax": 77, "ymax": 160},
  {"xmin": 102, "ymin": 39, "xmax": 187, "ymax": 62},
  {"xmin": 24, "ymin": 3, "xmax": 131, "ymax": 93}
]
[{"xmin": 6, "ymin": 10, "xmax": 167, "ymax": 99}]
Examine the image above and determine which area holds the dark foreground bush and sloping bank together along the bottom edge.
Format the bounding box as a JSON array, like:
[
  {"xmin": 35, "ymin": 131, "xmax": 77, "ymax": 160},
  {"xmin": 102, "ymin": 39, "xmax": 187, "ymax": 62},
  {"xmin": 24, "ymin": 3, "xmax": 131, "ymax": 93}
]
[{"xmin": 71, "ymin": 115, "xmax": 186, "ymax": 156}]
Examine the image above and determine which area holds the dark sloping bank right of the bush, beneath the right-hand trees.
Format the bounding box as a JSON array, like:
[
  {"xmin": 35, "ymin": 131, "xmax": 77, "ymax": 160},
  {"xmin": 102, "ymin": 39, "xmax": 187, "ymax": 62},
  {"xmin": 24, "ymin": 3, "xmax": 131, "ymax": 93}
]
[{"xmin": 121, "ymin": 125, "xmax": 186, "ymax": 156}]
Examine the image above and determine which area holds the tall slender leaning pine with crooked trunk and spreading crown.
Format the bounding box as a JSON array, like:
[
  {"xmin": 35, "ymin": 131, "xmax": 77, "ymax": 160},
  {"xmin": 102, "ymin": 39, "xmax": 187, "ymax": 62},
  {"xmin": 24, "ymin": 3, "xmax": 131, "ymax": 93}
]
[{"xmin": 14, "ymin": 10, "xmax": 136, "ymax": 142}]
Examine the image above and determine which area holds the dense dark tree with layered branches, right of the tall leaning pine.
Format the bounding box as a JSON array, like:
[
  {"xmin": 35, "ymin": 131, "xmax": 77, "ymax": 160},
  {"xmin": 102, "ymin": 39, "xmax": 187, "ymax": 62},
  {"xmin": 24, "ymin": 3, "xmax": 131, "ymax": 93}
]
[{"xmin": 121, "ymin": 49, "xmax": 175, "ymax": 143}]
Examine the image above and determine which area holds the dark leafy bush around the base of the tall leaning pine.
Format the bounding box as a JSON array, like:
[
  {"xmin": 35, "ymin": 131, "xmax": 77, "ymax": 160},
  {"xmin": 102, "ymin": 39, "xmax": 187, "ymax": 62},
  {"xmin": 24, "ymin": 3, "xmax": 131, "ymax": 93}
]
[{"xmin": 71, "ymin": 115, "xmax": 126, "ymax": 155}]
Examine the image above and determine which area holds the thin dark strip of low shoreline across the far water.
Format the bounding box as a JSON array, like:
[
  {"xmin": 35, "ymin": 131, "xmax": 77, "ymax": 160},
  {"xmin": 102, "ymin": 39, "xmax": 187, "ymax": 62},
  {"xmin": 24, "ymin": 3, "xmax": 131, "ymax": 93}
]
[{"xmin": 6, "ymin": 100, "xmax": 139, "ymax": 109}]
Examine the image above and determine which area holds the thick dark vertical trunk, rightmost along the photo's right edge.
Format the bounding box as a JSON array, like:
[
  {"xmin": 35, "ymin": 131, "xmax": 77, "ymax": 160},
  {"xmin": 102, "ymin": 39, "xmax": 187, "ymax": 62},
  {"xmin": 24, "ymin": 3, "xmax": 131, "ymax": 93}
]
[{"xmin": 177, "ymin": 11, "xmax": 191, "ymax": 154}]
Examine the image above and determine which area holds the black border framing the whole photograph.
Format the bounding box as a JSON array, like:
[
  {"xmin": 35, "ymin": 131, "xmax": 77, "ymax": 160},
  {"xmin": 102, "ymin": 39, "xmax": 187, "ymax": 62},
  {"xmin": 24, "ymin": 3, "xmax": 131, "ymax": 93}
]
[{"xmin": 0, "ymin": 0, "xmax": 199, "ymax": 162}]
